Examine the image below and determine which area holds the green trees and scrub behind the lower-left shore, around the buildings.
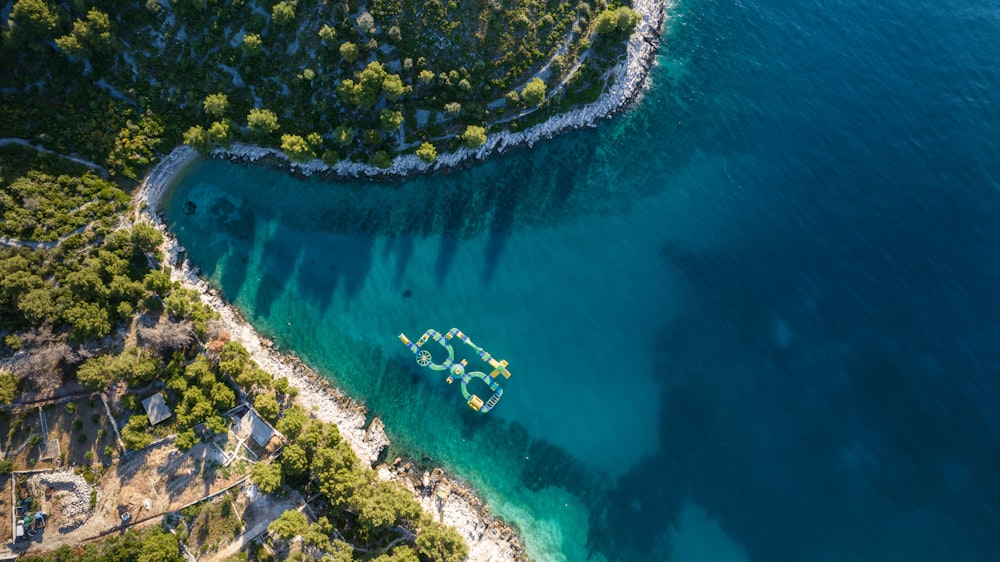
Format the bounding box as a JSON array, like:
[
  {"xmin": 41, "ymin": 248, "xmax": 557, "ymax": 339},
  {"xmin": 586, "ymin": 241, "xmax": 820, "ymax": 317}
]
[{"xmin": 0, "ymin": 146, "xmax": 466, "ymax": 562}]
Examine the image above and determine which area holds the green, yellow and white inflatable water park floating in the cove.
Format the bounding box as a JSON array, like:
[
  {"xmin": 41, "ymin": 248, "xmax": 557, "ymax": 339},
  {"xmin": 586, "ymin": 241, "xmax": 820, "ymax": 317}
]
[{"xmin": 399, "ymin": 328, "xmax": 510, "ymax": 414}]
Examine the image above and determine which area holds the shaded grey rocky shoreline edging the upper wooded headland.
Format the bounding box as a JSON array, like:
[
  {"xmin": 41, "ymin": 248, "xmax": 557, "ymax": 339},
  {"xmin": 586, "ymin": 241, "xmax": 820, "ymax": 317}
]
[{"xmin": 210, "ymin": 0, "xmax": 667, "ymax": 179}]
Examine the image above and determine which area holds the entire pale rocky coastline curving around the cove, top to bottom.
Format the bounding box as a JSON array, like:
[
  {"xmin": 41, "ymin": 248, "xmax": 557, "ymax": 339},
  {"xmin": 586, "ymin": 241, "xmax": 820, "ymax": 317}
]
[{"xmin": 133, "ymin": 0, "xmax": 666, "ymax": 562}]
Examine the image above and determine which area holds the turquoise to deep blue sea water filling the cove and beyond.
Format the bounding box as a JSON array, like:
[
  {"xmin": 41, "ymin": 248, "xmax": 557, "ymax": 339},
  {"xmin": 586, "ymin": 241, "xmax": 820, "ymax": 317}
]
[{"xmin": 166, "ymin": 0, "xmax": 1000, "ymax": 562}]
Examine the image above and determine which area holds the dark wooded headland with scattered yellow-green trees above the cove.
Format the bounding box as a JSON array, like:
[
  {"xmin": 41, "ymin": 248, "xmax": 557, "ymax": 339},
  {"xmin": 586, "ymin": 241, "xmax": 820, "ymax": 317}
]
[{"xmin": 0, "ymin": 0, "xmax": 638, "ymax": 168}]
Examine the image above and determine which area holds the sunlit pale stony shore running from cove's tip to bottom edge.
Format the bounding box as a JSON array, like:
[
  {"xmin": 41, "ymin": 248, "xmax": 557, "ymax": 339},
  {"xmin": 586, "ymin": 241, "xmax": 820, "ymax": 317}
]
[{"xmin": 140, "ymin": 146, "xmax": 526, "ymax": 562}]
